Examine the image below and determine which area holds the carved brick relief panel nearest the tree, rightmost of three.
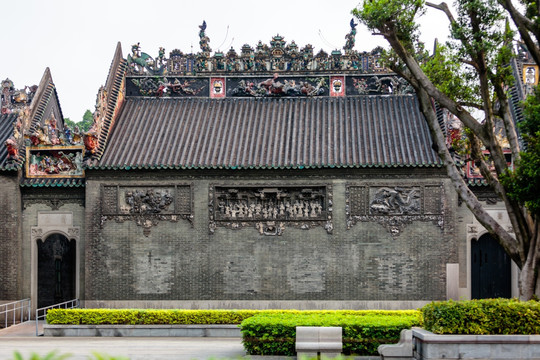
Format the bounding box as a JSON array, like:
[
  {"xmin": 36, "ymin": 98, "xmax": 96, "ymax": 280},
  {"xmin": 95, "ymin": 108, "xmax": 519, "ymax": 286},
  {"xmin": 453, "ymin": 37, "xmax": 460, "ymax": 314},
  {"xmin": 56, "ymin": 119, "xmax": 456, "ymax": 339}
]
[{"xmin": 346, "ymin": 184, "xmax": 444, "ymax": 237}]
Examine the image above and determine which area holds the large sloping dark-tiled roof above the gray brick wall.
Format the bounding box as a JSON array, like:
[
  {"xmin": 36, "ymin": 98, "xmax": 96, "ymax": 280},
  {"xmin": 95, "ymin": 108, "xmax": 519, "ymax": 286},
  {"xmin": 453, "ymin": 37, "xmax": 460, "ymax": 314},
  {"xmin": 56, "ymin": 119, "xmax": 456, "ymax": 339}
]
[{"xmin": 95, "ymin": 95, "xmax": 441, "ymax": 169}]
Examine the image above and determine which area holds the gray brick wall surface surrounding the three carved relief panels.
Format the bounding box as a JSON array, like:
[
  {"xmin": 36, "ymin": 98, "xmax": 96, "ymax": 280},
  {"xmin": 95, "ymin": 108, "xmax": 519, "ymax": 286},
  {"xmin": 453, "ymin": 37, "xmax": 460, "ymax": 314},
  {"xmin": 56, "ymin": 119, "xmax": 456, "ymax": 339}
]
[{"xmin": 84, "ymin": 169, "xmax": 460, "ymax": 301}]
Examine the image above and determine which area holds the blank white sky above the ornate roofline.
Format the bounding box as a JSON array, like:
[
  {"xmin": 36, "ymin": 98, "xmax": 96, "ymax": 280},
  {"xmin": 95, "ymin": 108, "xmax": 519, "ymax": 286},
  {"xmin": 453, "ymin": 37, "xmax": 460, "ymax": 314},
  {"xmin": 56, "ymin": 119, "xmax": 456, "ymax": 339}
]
[{"xmin": 0, "ymin": 0, "xmax": 448, "ymax": 121}]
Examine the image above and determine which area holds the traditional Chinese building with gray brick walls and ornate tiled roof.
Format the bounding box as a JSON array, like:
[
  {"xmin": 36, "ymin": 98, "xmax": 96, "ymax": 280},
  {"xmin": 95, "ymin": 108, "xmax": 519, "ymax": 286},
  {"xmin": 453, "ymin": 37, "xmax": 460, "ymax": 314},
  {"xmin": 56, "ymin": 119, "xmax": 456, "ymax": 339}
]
[{"xmin": 0, "ymin": 23, "xmax": 517, "ymax": 308}]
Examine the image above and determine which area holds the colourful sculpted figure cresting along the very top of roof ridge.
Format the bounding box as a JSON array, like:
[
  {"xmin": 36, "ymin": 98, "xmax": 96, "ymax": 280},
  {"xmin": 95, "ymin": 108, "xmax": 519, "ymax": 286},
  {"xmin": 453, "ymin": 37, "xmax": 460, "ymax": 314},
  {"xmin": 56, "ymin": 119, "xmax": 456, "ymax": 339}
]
[{"xmin": 127, "ymin": 20, "xmax": 388, "ymax": 76}]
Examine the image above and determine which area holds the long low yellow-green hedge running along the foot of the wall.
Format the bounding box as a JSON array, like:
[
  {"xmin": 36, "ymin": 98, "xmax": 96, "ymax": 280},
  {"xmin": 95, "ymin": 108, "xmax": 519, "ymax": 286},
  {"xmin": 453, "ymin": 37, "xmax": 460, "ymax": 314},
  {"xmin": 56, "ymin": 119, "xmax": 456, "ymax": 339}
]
[{"xmin": 47, "ymin": 309, "xmax": 415, "ymax": 325}]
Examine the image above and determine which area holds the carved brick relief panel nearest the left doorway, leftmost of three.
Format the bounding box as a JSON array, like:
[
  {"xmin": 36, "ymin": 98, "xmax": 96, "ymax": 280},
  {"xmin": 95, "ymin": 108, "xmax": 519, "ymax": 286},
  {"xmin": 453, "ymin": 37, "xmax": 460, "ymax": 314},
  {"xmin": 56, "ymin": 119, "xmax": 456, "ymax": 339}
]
[{"xmin": 101, "ymin": 185, "xmax": 193, "ymax": 236}]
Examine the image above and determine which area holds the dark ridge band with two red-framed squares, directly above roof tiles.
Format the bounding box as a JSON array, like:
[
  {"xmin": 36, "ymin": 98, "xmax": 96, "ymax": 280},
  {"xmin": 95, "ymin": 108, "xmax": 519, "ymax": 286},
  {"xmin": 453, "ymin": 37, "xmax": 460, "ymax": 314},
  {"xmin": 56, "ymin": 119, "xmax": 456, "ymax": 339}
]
[{"xmin": 126, "ymin": 72, "xmax": 414, "ymax": 98}]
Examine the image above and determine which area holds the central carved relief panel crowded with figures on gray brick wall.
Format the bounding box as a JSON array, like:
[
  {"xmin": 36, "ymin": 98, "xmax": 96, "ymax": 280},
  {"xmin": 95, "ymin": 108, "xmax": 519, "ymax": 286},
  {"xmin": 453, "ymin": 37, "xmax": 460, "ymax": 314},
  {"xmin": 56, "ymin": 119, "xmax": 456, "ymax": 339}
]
[{"xmin": 209, "ymin": 186, "xmax": 333, "ymax": 235}]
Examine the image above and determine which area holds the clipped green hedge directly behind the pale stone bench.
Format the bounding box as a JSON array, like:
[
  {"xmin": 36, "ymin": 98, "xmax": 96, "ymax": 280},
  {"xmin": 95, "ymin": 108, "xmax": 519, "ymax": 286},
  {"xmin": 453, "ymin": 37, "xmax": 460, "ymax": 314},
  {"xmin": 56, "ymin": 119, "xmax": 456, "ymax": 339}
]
[{"xmin": 241, "ymin": 310, "xmax": 421, "ymax": 356}]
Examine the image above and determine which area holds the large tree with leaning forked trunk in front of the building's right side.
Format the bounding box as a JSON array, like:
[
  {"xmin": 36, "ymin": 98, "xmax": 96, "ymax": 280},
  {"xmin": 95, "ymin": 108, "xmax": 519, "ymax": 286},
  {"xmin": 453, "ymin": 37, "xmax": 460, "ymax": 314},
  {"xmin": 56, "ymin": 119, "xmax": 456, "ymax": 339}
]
[{"xmin": 353, "ymin": 0, "xmax": 540, "ymax": 300}]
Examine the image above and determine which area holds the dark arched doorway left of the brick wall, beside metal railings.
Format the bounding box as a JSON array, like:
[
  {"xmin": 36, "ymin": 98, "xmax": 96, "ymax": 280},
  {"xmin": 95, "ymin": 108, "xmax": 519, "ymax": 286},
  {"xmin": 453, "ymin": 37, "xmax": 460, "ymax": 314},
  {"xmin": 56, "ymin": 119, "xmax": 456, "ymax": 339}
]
[{"xmin": 37, "ymin": 233, "xmax": 76, "ymax": 308}]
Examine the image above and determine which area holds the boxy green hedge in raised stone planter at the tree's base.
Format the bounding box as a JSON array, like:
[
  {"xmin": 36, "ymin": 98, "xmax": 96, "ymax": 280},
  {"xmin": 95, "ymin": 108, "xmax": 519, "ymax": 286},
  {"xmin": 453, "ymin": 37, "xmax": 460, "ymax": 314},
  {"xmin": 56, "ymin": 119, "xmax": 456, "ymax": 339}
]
[{"xmin": 421, "ymin": 299, "xmax": 540, "ymax": 335}]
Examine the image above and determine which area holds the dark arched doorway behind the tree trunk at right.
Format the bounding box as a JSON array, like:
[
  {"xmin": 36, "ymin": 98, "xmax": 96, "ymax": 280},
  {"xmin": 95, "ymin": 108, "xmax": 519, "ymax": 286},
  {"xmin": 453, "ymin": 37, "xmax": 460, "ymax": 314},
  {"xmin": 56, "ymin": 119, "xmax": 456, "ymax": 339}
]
[{"xmin": 471, "ymin": 234, "xmax": 512, "ymax": 299}]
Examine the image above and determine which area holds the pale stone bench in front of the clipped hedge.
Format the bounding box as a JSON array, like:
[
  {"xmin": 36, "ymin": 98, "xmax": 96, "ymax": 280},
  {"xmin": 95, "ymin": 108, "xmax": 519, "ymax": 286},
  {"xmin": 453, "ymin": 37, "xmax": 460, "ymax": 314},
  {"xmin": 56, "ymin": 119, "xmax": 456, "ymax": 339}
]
[{"xmin": 296, "ymin": 326, "xmax": 343, "ymax": 358}]
